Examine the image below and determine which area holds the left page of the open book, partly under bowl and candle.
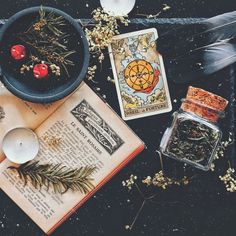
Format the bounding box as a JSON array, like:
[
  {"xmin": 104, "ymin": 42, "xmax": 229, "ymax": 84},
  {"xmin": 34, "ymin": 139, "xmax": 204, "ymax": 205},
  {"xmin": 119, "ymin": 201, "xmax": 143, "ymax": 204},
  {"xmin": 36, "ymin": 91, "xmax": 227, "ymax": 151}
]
[{"xmin": 0, "ymin": 82, "xmax": 65, "ymax": 162}]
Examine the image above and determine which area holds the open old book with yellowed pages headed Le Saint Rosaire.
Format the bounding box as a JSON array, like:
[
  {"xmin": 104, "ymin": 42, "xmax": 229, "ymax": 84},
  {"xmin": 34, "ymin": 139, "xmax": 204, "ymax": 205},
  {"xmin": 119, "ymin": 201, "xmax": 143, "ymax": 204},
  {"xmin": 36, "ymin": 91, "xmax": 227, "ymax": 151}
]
[{"xmin": 0, "ymin": 83, "xmax": 144, "ymax": 234}]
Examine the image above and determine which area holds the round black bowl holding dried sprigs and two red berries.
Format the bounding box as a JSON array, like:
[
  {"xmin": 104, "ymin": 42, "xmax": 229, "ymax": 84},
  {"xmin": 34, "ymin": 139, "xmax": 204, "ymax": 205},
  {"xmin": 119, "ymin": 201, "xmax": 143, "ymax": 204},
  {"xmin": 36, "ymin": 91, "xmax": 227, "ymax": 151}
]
[{"xmin": 0, "ymin": 7, "xmax": 89, "ymax": 103}]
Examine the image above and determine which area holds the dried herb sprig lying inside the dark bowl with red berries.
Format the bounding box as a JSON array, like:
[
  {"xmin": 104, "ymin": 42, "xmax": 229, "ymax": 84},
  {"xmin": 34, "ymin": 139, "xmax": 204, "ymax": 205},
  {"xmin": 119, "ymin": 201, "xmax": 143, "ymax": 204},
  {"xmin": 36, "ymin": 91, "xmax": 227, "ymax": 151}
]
[{"xmin": 18, "ymin": 7, "xmax": 76, "ymax": 77}]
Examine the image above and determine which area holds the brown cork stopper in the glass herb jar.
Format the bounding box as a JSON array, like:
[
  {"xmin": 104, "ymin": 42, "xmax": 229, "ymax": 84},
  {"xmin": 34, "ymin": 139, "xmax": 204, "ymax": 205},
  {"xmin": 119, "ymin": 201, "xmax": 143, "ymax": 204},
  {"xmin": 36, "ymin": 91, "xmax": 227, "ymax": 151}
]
[{"xmin": 181, "ymin": 86, "xmax": 228, "ymax": 122}]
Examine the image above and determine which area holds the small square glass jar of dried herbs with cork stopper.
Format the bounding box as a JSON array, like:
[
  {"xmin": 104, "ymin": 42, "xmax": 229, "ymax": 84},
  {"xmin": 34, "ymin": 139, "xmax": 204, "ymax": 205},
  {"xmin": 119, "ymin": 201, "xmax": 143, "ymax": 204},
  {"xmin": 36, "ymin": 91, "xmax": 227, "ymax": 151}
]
[{"xmin": 160, "ymin": 86, "xmax": 228, "ymax": 171}]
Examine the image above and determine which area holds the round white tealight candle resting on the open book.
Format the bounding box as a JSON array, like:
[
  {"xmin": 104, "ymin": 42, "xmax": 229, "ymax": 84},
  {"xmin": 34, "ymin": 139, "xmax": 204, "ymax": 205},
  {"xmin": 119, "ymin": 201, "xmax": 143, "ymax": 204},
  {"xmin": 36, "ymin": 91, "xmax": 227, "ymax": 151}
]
[{"xmin": 2, "ymin": 128, "xmax": 39, "ymax": 164}]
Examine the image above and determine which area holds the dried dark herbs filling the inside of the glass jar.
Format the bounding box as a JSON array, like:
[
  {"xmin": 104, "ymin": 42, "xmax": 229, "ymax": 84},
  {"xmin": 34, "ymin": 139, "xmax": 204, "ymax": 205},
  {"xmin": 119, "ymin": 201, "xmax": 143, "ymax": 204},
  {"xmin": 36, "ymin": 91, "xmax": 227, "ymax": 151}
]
[{"xmin": 167, "ymin": 119, "xmax": 220, "ymax": 165}]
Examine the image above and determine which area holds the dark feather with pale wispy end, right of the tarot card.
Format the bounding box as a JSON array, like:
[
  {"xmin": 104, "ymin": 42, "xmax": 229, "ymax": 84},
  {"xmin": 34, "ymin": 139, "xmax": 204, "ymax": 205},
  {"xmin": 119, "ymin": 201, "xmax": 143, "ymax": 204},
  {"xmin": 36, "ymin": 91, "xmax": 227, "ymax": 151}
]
[{"xmin": 157, "ymin": 11, "xmax": 236, "ymax": 83}]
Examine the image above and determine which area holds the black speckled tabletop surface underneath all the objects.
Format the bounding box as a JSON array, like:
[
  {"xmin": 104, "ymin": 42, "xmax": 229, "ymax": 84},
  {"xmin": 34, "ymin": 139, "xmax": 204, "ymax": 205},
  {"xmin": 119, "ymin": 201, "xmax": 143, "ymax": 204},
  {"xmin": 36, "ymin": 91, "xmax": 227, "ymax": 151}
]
[{"xmin": 0, "ymin": 0, "xmax": 236, "ymax": 236}]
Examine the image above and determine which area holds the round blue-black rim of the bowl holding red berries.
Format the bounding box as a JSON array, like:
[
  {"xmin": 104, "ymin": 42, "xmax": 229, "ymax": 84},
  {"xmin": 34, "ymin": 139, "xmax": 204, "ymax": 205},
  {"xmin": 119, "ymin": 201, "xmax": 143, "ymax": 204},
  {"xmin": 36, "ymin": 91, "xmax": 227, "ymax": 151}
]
[{"xmin": 0, "ymin": 6, "xmax": 90, "ymax": 103}]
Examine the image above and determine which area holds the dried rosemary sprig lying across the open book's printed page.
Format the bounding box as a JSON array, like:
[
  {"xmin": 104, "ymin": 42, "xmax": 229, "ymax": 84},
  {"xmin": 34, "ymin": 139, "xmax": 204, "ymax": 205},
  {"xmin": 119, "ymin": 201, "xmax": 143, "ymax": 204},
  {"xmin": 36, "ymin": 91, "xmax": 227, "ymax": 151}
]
[{"xmin": 8, "ymin": 161, "xmax": 96, "ymax": 194}]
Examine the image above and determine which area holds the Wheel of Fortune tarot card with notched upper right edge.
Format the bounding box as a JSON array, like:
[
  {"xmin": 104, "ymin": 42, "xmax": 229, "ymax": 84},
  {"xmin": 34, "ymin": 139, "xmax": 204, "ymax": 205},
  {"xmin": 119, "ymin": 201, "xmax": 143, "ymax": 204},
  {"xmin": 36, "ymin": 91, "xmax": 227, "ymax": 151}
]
[{"xmin": 109, "ymin": 28, "xmax": 172, "ymax": 120}]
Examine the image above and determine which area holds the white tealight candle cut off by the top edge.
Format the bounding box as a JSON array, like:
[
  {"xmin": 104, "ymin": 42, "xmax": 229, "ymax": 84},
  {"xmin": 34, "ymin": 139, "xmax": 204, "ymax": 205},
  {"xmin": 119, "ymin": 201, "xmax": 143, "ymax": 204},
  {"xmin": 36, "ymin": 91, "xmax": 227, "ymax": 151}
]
[{"xmin": 100, "ymin": 0, "xmax": 135, "ymax": 16}]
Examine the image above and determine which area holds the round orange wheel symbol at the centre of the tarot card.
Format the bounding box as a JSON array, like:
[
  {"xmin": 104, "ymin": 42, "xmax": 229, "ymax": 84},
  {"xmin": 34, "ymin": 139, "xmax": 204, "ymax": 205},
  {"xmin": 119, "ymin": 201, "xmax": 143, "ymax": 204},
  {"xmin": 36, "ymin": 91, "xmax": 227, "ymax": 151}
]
[{"xmin": 124, "ymin": 60, "xmax": 160, "ymax": 94}]
